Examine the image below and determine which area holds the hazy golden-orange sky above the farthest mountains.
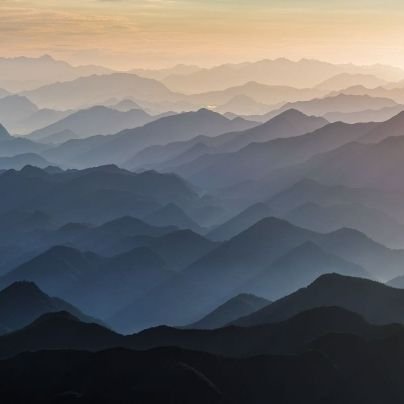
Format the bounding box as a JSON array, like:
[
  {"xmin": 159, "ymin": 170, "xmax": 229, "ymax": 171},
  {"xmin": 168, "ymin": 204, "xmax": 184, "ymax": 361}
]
[{"xmin": 0, "ymin": 0, "xmax": 404, "ymax": 68}]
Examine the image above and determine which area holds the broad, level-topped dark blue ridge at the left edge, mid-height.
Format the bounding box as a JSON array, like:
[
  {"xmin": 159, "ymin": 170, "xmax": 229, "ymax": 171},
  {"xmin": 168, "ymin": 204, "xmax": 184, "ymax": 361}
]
[{"xmin": 0, "ymin": 166, "xmax": 199, "ymax": 224}]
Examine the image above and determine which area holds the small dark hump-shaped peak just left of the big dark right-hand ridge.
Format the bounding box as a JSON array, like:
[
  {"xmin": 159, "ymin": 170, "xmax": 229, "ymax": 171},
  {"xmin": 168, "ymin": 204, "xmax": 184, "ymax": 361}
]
[{"xmin": 189, "ymin": 293, "xmax": 270, "ymax": 330}]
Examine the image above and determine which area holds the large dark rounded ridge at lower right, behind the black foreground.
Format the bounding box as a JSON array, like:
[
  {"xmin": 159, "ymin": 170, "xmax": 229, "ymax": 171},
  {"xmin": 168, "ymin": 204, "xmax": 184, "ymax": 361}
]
[{"xmin": 235, "ymin": 274, "xmax": 404, "ymax": 326}]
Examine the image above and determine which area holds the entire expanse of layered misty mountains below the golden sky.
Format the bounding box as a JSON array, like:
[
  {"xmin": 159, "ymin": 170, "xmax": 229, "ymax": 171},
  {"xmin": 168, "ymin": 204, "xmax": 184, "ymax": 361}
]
[{"xmin": 0, "ymin": 57, "xmax": 404, "ymax": 404}]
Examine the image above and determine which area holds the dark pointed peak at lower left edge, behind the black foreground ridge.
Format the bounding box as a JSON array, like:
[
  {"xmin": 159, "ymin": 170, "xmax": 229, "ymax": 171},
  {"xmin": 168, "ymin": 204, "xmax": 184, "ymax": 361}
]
[{"xmin": 0, "ymin": 282, "xmax": 96, "ymax": 332}]
